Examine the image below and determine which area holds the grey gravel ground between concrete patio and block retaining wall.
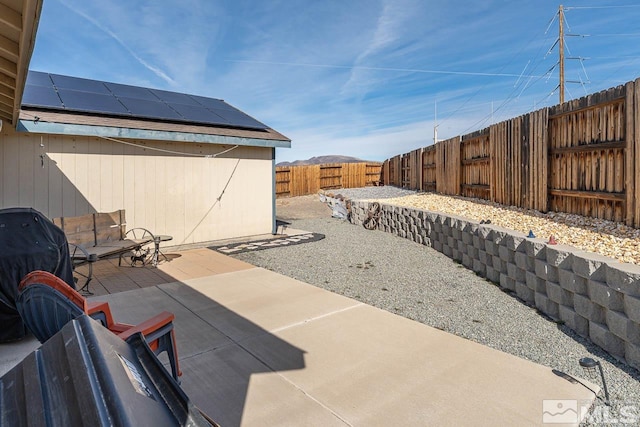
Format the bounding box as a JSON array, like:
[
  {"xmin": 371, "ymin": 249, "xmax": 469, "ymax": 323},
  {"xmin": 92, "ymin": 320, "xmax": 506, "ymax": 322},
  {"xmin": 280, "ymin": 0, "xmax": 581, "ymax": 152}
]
[{"xmin": 234, "ymin": 187, "xmax": 640, "ymax": 425}]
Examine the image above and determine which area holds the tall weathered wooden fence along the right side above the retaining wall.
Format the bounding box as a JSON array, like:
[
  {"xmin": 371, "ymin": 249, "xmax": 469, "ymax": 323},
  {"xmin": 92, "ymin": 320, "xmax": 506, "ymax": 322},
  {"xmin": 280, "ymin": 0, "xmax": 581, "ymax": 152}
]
[{"xmin": 381, "ymin": 79, "xmax": 640, "ymax": 227}]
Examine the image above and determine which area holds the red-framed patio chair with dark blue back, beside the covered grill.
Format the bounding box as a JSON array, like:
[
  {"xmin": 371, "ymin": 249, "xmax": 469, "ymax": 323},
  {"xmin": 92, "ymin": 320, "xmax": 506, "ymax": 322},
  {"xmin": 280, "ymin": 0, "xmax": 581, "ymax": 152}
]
[{"xmin": 16, "ymin": 271, "xmax": 182, "ymax": 381}]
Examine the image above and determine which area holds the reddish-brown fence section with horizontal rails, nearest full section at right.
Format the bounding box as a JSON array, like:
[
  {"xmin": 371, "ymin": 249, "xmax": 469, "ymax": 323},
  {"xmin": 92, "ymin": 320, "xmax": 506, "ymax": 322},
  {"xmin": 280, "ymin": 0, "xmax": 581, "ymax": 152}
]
[{"xmin": 549, "ymin": 86, "xmax": 633, "ymax": 221}]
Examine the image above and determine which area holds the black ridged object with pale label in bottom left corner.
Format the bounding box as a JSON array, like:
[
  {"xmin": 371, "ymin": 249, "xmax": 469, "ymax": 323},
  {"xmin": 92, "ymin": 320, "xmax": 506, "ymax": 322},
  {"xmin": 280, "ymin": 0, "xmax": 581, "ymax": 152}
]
[{"xmin": 0, "ymin": 315, "xmax": 216, "ymax": 427}]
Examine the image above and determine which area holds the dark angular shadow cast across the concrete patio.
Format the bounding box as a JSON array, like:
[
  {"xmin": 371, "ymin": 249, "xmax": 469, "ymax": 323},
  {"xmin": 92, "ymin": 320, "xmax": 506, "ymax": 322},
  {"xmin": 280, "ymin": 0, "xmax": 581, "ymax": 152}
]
[{"xmin": 101, "ymin": 282, "xmax": 305, "ymax": 426}]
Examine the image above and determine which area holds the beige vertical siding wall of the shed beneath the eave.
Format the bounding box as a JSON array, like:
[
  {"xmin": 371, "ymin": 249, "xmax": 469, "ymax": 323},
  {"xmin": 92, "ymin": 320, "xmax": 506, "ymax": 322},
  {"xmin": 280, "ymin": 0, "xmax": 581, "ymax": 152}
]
[{"xmin": 0, "ymin": 129, "xmax": 274, "ymax": 244}]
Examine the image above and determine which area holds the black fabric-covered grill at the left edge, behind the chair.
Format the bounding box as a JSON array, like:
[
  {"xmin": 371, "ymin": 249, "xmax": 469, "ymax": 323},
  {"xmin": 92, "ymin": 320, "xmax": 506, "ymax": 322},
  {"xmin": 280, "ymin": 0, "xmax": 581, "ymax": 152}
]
[{"xmin": 0, "ymin": 208, "xmax": 74, "ymax": 342}]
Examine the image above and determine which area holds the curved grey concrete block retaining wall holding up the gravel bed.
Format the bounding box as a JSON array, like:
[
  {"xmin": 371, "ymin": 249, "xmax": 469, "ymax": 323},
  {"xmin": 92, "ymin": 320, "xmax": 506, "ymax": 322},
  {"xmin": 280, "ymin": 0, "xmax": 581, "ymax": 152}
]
[{"xmin": 351, "ymin": 201, "xmax": 640, "ymax": 369}]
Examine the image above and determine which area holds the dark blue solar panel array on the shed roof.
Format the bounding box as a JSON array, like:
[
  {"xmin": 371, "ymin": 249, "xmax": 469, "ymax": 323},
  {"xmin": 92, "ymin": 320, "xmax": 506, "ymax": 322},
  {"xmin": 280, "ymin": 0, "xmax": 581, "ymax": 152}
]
[{"xmin": 22, "ymin": 71, "xmax": 268, "ymax": 130}]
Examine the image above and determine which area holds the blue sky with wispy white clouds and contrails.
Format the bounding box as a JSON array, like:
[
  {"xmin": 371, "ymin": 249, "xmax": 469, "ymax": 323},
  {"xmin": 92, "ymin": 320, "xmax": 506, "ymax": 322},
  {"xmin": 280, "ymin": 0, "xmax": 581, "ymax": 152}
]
[{"xmin": 30, "ymin": 0, "xmax": 640, "ymax": 162}]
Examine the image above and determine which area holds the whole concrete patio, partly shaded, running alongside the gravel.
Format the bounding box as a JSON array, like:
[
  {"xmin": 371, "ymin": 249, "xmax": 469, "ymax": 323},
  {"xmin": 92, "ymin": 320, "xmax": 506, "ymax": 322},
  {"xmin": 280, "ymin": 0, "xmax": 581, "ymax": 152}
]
[{"xmin": 0, "ymin": 252, "xmax": 597, "ymax": 426}]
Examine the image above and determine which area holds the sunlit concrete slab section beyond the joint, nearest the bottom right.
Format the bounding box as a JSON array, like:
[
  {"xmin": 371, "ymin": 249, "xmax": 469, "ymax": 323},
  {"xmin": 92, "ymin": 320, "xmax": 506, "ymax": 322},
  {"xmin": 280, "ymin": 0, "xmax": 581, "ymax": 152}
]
[{"xmin": 243, "ymin": 305, "xmax": 593, "ymax": 425}]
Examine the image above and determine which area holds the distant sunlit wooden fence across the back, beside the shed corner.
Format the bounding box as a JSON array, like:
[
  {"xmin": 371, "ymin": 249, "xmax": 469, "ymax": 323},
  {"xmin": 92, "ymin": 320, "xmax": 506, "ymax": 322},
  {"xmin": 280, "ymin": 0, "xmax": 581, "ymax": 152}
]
[{"xmin": 276, "ymin": 163, "xmax": 383, "ymax": 197}]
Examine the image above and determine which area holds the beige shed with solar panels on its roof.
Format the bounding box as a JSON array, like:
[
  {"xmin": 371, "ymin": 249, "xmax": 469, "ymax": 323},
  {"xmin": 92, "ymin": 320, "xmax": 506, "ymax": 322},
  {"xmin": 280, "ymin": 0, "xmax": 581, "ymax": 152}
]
[{"xmin": 0, "ymin": 71, "xmax": 290, "ymax": 244}]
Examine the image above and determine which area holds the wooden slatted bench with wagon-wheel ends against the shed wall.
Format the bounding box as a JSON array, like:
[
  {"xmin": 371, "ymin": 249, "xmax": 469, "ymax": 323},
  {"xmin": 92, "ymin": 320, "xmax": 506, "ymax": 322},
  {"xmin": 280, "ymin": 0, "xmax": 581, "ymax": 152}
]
[{"xmin": 53, "ymin": 209, "xmax": 154, "ymax": 294}]
